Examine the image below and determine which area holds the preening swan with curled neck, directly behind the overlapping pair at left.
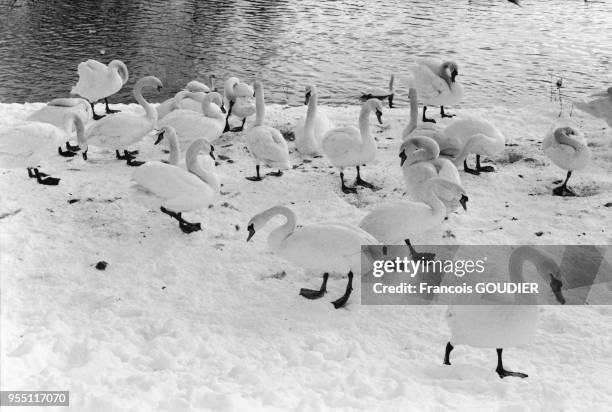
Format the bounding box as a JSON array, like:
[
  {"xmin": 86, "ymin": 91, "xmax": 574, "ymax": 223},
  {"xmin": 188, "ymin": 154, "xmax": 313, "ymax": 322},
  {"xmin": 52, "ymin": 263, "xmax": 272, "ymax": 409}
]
[{"xmin": 157, "ymin": 92, "xmax": 225, "ymax": 145}]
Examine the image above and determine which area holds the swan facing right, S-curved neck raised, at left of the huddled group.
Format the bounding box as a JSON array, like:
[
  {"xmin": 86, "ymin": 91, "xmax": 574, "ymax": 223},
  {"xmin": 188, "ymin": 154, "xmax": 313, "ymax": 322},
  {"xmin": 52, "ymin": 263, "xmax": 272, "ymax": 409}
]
[{"xmin": 83, "ymin": 76, "xmax": 162, "ymax": 166}]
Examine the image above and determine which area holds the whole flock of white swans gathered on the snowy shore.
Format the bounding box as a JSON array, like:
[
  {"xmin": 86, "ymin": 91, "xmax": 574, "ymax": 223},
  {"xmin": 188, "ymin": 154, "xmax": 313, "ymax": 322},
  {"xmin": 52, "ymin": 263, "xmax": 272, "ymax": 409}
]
[{"xmin": 0, "ymin": 59, "xmax": 612, "ymax": 377}]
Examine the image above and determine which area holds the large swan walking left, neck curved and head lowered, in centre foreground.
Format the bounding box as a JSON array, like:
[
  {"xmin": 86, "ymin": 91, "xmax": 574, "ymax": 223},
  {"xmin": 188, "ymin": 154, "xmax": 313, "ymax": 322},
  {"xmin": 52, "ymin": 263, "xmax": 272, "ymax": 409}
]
[{"xmin": 247, "ymin": 206, "xmax": 377, "ymax": 309}]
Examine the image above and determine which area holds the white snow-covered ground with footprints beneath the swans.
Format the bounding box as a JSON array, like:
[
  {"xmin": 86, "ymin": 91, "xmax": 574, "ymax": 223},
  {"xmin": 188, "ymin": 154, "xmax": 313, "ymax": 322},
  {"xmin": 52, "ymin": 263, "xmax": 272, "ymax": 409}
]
[{"xmin": 0, "ymin": 100, "xmax": 612, "ymax": 412}]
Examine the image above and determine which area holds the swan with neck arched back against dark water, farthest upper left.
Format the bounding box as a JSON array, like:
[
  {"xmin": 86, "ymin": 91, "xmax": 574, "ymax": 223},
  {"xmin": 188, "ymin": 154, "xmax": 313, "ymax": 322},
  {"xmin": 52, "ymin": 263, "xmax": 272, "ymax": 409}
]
[{"xmin": 71, "ymin": 59, "xmax": 129, "ymax": 120}]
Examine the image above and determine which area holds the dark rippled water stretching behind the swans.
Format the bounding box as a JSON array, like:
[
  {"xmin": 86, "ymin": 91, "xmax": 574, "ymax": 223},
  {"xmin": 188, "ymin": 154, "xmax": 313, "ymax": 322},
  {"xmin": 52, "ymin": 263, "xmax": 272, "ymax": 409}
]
[{"xmin": 0, "ymin": 0, "xmax": 612, "ymax": 106}]
